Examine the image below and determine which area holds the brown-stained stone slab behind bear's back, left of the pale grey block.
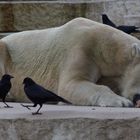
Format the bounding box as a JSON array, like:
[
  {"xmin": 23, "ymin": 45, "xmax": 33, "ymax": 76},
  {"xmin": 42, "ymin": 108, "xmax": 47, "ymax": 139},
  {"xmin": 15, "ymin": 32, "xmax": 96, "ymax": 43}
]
[{"xmin": 0, "ymin": 2, "xmax": 103, "ymax": 31}]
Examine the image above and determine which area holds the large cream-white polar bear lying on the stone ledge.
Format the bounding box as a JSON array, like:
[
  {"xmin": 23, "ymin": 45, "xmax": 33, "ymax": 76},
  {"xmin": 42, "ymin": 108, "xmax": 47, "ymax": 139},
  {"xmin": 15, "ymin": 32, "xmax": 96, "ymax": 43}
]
[{"xmin": 0, "ymin": 17, "xmax": 140, "ymax": 107}]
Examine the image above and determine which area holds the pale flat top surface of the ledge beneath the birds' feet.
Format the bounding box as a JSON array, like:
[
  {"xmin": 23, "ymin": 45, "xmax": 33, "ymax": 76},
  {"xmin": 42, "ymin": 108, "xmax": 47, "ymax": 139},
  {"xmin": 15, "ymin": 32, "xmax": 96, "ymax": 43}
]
[{"xmin": 0, "ymin": 102, "xmax": 140, "ymax": 120}]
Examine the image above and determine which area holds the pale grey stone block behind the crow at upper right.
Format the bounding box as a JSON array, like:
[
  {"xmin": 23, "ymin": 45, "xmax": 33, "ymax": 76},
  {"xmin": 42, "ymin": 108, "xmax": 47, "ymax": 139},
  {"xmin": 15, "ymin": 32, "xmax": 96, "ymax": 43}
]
[{"xmin": 104, "ymin": 0, "xmax": 140, "ymax": 25}]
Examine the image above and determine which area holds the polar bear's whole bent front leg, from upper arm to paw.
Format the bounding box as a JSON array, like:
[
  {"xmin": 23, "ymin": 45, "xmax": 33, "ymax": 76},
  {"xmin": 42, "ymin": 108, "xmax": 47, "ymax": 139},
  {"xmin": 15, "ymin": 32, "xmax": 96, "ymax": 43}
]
[{"xmin": 58, "ymin": 48, "xmax": 132, "ymax": 107}]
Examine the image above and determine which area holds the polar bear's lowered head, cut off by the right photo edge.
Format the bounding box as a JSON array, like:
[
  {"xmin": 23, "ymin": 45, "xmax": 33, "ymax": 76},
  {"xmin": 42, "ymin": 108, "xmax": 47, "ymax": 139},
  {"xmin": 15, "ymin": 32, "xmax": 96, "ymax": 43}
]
[{"xmin": 122, "ymin": 43, "xmax": 140, "ymax": 104}]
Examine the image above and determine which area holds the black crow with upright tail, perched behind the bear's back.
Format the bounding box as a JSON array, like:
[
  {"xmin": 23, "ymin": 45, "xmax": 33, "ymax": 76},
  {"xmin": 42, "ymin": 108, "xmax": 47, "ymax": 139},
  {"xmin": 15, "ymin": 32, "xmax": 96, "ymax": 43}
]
[{"xmin": 102, "ymin": 14, "xmax": 140, "ymax": 34}]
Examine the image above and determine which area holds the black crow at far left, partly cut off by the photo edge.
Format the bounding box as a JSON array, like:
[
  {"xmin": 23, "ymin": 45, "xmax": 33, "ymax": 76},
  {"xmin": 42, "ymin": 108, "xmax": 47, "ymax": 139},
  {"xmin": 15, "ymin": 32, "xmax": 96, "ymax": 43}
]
[{"xmin": 0, "ymin": 74, "xmax": 14, "ymax": 108}]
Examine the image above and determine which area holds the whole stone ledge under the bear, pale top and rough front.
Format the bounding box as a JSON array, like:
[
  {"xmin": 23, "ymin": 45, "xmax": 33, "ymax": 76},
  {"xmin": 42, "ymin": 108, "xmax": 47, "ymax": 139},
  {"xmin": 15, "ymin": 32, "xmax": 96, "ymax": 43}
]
[{"xmin": 0, "ymin": 103, "xmax": 140, "ymax": 140}]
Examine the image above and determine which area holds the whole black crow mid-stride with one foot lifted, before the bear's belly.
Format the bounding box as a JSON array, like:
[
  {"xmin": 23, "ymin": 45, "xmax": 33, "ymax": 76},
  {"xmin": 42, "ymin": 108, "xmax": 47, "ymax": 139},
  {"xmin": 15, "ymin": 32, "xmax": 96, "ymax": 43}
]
[{"xmin": 21, "ymin": 77, "xmax": 71, "ymax": 115}]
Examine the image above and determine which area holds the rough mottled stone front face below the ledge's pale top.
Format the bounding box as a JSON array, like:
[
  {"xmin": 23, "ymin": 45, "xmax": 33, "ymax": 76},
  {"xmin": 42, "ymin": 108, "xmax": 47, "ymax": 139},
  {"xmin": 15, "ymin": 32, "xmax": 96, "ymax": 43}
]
[{"xmin": 0, "ymin": 118, "xmax": 140, "ymax": 140}]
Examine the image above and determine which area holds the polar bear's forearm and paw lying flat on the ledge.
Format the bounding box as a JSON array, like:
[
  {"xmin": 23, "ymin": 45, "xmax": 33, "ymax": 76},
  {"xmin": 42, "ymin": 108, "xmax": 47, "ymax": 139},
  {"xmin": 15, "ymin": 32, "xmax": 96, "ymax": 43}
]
[{"xmin": 60, "ymin": 80, "xmax": 132, "ymax": 107}]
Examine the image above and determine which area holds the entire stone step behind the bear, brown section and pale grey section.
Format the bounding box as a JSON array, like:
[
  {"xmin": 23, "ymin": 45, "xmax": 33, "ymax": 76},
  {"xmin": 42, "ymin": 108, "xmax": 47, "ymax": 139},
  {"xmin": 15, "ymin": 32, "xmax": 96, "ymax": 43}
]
[{"xmin": 0, "ymin": 0, "xmax": 140, "ymax": 32}]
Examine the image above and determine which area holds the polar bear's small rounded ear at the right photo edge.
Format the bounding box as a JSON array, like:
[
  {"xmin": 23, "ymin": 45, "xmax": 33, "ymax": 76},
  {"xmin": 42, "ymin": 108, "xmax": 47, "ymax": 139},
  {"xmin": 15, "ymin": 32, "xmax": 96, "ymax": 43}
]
[{"xmin": 131, "ymin": 43, "xmax": 140, "ymax": 57}]
